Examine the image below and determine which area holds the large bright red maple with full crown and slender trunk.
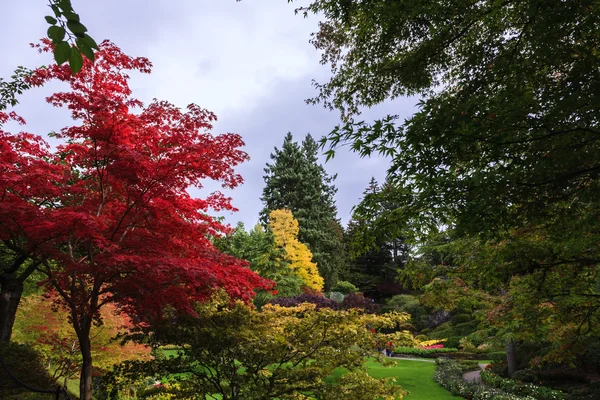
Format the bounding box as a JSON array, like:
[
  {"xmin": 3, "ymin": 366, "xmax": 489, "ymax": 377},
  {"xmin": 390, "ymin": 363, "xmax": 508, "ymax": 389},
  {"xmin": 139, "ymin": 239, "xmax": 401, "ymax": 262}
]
[{"xmin": 24, "ymin": 42, "xmax": 271, "ymax": 400}]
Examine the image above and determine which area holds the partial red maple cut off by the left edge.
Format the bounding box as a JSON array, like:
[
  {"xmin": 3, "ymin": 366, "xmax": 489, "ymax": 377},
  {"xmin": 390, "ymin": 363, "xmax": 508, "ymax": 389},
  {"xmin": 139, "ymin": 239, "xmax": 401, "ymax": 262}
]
[{"xmin": 0, "ymin": 112, "xmax": 67, "ymax": 342}]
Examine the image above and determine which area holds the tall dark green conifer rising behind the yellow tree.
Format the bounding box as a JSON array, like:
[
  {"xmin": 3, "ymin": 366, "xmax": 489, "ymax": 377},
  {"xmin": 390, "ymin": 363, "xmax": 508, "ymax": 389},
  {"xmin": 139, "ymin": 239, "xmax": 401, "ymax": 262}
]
[{"xmin": 260, "ymin": 133, "xmax": 343, "ymax": 290}]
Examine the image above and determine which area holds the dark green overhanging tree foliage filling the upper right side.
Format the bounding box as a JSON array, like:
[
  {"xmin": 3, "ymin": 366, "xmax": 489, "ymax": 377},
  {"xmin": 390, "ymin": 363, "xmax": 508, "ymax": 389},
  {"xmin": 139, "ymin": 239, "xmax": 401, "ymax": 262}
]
[{"xmin": 294, "ymin": 0, "xmax": 600, "ymax": 363}]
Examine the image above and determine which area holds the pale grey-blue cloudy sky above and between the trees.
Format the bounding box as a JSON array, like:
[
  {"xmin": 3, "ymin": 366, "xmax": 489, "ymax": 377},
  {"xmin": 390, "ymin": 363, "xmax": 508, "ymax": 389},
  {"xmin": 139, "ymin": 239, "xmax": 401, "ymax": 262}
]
[{"xmin": 0, "ymin": 0, "xmax": 416, "ymax": 225}]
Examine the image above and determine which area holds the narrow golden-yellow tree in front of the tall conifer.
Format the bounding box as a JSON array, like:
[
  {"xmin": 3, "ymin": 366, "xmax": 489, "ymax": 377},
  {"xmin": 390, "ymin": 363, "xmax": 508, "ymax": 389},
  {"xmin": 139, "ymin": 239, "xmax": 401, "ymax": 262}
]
[{"xmin": 269, "ymin": 210, "xmax": 324, "ymax": 291}]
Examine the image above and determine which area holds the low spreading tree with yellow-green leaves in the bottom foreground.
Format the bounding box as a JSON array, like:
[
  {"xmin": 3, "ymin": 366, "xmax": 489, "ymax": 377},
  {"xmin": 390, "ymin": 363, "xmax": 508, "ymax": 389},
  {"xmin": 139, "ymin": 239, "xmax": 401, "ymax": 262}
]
[{"xmin": 109, "ymin": 298, "xmax": 408, "ymax": 400}]
